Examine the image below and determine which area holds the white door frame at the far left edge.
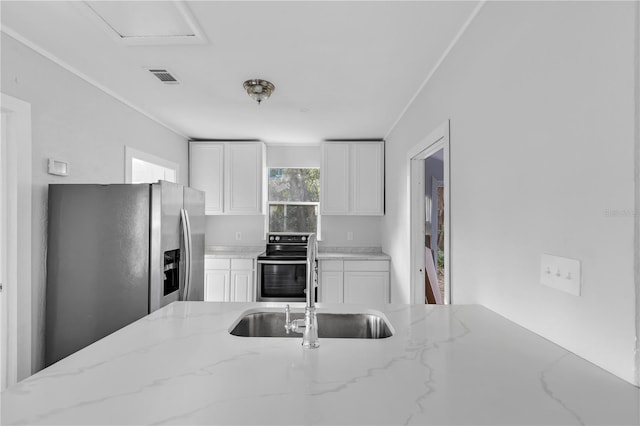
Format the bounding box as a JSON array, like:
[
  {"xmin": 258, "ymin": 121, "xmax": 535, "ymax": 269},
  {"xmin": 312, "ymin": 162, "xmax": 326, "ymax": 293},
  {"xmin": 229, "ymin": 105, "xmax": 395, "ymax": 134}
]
[{"xmin": 0, "ymin": 93, "xmax": 32, "ymax": 386}]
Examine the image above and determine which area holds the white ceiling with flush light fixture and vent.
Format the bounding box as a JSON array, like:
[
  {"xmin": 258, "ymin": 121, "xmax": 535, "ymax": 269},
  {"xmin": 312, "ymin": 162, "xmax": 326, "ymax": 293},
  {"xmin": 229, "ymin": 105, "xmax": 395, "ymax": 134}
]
[{"xmin": 0, "ymin": 0, "xmax": 477, "ymax": 144}]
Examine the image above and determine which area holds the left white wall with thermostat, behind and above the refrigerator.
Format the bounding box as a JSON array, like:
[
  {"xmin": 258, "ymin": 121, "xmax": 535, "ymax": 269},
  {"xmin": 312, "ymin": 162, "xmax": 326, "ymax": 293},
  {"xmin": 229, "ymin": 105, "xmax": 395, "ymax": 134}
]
[{"xmin": 1, "ymin": 33, "xmax": 188, "ymax": 371}]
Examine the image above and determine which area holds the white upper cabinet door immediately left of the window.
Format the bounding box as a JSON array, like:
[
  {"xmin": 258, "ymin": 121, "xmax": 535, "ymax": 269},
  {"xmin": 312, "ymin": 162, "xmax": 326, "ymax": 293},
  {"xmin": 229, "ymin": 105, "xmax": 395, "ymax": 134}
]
[{"xmin": 225, "ymin": 142, "xmax": 266, "ymax": 214}]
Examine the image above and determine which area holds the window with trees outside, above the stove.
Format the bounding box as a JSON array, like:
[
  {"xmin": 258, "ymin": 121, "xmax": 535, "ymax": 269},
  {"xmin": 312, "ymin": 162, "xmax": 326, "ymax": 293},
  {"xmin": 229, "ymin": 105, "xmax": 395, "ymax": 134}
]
[{"xmin": 268, "ymin": 168, "xmax": 320, "ymax": 234}]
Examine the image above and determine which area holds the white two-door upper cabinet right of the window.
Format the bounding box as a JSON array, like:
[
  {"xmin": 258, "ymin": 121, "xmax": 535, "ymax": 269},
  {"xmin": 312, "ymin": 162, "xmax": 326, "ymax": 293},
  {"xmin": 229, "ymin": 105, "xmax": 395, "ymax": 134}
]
[{"xmin": 320, "ymin": 141, "xmax": 384, "ymax": 216}]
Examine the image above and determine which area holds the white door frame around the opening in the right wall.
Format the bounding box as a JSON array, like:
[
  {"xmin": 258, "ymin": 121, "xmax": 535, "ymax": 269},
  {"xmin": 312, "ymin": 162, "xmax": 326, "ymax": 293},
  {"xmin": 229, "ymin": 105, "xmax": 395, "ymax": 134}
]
[{"xmin": 407, "ymin": 120, "xmax": 451, "ymax": 304}]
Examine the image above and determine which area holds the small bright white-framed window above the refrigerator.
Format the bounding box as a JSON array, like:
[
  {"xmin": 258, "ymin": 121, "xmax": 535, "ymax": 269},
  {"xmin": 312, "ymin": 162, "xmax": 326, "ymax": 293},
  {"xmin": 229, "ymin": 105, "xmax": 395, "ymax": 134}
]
[{"xmin": 125, "ymin": 146, "xmax": 178, "ymax": 183}]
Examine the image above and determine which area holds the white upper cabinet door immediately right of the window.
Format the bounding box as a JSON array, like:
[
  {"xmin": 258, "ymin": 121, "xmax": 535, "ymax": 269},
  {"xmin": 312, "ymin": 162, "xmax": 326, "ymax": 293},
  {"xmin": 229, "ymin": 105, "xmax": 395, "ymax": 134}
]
[{"xmin": 320, "ymin": 142, "xmax": 350, "ymax": 215}]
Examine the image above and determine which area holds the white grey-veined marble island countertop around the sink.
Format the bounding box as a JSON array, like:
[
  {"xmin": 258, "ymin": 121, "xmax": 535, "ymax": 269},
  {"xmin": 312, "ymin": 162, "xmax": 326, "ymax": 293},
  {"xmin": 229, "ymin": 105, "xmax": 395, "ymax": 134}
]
[{"xmin": 1, "ymin": 302, "xmax": 640, "ymax": 425}]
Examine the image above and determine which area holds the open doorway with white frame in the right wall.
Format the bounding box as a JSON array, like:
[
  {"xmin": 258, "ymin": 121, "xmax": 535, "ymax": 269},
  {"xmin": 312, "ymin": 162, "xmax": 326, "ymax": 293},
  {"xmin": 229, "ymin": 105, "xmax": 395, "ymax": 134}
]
[{"xmin": 408, "ymin": 120, "xmax": 451, "ymax": 304}]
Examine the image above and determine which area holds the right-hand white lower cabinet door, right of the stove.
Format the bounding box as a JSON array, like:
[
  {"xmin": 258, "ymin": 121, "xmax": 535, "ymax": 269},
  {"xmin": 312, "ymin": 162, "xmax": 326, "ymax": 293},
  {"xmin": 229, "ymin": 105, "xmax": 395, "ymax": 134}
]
[{"xmin": 344, "ymin": 272, "xmax": 389, "ymax": 305}]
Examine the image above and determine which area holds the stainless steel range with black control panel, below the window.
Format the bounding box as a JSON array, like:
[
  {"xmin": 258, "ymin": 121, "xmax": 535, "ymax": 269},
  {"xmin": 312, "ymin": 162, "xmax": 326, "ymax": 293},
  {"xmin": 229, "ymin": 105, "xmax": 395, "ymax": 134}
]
[{"xmin": 257, "ymin": 233, "xmax": 317, "ymax": 302}]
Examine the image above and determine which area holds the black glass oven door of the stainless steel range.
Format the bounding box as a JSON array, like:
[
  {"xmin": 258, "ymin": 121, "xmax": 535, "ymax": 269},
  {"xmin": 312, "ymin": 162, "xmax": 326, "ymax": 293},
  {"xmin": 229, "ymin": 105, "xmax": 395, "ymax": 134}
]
[{"xmin": 257, "ymin": 259, "xmax": 307, "ymax": 302}]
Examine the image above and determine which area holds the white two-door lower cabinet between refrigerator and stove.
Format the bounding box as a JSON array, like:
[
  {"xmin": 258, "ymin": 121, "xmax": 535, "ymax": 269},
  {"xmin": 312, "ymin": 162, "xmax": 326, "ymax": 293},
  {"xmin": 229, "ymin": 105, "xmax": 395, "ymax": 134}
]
[{"xmin": 204, "ymin": 259, "xmax": 255, "ymax": 302}]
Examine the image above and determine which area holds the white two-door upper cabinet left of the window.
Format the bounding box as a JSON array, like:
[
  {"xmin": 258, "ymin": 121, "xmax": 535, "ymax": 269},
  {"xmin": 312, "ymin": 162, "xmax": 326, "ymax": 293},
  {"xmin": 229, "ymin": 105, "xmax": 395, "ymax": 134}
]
[{"xmin": 189, "ymin": 142, "xmax": 265, "ymax": 215}]
